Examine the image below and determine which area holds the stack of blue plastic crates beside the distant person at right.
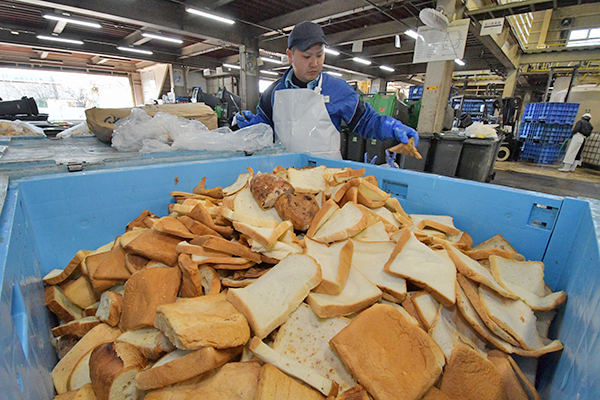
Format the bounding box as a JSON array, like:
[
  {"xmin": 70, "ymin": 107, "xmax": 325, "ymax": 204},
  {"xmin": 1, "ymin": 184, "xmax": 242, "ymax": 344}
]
[{"xmin": 519, "ymin": 103, "xmax": 579, "ymax": 164}]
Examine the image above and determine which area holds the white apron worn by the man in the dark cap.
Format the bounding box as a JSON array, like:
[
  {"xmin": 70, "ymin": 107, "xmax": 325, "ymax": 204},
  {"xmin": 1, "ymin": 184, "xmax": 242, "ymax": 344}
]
[{"xmin": 273, "ymin": 77, "xmax": 342, "ymax": 159}]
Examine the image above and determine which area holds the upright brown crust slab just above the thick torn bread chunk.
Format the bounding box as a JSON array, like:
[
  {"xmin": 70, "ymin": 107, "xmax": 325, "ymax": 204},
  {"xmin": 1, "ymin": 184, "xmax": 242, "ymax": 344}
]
[{"xmin": 121, "ymin": 266, "xmax": 181, "ymax": 331}]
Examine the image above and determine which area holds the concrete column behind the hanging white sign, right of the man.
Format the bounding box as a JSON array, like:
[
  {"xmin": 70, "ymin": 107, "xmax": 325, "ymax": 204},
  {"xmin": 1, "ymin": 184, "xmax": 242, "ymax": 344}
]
[{"xmin": 417, "ymin": 0, "xmax": 464, "ymax": 133}]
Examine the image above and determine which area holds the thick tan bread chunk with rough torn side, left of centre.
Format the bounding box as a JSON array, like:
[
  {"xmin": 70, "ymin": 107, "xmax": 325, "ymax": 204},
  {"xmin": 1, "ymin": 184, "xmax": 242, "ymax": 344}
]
[{"xmin": 154, "ymin": 293, "xmax": 250, "ymax": 350}]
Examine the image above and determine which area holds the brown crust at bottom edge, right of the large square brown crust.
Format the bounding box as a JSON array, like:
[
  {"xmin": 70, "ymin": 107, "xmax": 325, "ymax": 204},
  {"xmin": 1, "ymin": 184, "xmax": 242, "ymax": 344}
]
[{"xmin": 440, "ymin": 345, "xmax": 508, "ymax": 400}]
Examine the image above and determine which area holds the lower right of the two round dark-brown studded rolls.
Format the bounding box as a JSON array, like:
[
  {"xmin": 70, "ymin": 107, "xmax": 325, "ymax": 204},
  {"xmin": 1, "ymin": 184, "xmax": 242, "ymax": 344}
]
[{"xmin": 275, "ymin": 193, "xmax": 319, "ymax": 232}]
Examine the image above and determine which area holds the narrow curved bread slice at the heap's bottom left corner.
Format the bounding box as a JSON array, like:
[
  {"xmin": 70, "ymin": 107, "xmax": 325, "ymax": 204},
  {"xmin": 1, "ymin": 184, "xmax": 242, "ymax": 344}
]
[{"xmin": 52, "ymin": 324, "xmax": 121, "ymax": 394}]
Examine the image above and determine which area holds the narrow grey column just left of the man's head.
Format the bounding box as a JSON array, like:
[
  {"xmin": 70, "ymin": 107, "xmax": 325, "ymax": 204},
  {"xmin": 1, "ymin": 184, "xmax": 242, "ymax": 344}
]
[{"xmin": 240, "ymin": 37, "xmax": 260, "ymax": 112}]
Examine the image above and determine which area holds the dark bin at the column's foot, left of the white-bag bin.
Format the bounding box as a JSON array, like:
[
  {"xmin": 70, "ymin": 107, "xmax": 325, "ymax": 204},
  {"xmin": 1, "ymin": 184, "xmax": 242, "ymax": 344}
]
[{"xmin": 427, "ymin": 132, "xmax": 465, "ymax": 176}]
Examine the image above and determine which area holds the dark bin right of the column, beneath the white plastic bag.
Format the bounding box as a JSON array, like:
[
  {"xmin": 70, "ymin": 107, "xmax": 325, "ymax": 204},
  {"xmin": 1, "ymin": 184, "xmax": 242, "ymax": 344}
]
[{"xmin": 456, "ymin": 137, "xmax": 503, "ymax": 182}]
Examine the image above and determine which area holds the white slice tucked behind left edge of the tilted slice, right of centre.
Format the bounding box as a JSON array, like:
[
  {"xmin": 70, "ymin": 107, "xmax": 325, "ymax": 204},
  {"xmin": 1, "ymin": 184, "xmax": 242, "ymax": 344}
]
[{"xmin": 351, "ymin": 239, "xmax": 406, "ymax": 301}]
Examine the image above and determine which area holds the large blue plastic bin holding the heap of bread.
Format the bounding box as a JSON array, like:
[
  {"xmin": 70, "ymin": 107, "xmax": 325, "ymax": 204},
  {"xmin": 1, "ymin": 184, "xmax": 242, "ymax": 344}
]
[{"xmin": 0, "ymin": 154, "xmax": 600, "ymax": 400}]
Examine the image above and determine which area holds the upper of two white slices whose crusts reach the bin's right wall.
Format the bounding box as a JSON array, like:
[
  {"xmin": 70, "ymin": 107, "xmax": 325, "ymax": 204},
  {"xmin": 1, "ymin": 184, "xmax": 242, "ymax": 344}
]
[{"xmin": 490, "ymin": 256, "xmax": 567, "ymax": 311}]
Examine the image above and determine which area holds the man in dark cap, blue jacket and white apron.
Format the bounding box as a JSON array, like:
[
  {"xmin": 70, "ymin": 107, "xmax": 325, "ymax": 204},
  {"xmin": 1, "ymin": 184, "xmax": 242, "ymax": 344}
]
[{"xmin": 236, "ymin": 21, "xmax": 419, "ymax": 158}]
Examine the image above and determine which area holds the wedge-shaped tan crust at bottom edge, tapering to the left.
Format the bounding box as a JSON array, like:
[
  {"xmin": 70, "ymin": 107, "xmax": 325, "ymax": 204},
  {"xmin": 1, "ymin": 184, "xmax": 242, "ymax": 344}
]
[{"xmin": 144, "ymin": 362, "xmax": 260, "ymax": 400}]
